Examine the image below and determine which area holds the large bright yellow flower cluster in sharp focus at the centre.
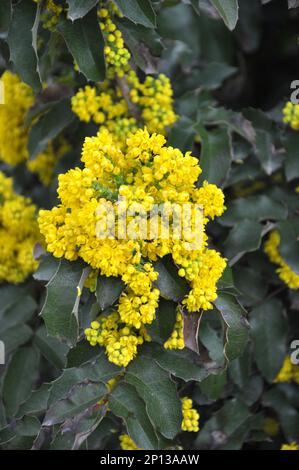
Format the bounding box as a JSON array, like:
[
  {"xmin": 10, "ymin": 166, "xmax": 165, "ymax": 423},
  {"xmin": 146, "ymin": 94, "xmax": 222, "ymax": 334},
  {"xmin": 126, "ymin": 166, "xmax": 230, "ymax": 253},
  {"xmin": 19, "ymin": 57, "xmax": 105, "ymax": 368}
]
[{"xmin": 39, "ymin": 129, "xmax": 225, "ymax": 366}]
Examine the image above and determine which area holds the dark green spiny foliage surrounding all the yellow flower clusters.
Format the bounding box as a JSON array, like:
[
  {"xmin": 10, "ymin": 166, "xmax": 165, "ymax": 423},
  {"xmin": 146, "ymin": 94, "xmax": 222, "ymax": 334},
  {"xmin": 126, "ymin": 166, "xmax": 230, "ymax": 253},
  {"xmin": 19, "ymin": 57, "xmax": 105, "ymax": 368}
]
[{"xmin": 0, "ymin": 0, "xmax": 299, "ymax": 449}]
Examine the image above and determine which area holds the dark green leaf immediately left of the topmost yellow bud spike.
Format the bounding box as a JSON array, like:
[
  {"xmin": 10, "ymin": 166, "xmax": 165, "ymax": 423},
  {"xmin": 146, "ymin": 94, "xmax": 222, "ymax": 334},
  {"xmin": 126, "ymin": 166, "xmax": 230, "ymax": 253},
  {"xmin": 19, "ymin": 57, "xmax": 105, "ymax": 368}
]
[{"xmin": 58, "ymin": 8, "xmax": 105, "ymax": 82}]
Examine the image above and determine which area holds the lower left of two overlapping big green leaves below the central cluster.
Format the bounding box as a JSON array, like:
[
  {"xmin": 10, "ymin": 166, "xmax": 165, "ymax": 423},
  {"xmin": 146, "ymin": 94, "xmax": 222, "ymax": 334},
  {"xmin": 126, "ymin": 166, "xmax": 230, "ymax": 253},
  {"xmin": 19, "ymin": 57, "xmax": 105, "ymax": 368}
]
[{"xmin": 108, "ymin": 383, "xmax": 159, "ymax": 450}]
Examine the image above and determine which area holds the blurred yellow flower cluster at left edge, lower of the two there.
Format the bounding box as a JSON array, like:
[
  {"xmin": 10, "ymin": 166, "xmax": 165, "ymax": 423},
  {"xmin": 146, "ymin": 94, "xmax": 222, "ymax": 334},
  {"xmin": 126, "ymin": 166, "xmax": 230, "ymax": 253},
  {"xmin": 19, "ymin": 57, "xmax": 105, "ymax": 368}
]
[{"xmin": 0, "ymin": 172, "xmax": 39, "ymax": 284}]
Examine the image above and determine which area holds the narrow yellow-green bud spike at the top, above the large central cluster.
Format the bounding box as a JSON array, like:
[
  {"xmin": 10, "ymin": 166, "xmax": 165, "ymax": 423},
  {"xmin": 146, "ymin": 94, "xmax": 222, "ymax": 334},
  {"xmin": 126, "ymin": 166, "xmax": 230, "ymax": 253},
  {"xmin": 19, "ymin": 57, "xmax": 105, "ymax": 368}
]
[{"xmin": 98, "ymin": 8, "xmax": 131, "ymax": 78}]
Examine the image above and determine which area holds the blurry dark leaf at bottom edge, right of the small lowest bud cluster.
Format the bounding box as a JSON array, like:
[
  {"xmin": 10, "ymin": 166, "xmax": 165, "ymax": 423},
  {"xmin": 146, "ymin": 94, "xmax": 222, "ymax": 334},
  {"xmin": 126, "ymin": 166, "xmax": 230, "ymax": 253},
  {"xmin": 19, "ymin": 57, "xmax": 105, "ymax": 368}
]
[{"xmin": 195, "ymin": 399, "xmax": 250, "ymax": 449}]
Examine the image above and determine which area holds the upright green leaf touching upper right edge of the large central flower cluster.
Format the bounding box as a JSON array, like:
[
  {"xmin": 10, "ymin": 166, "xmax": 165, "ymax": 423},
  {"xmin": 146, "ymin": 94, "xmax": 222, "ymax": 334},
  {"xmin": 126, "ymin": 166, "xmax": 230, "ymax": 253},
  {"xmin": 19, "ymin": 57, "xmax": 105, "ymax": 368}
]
[{"xmin": 197, "ymin": 125, "xmax": 232, "ymax": 187}]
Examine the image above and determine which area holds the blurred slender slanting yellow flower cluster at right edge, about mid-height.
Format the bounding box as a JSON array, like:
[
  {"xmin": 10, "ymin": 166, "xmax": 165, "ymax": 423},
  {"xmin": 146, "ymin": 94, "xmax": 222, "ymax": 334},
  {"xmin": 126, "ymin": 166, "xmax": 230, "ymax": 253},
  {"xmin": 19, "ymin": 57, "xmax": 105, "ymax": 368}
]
[{"xmin": 264, "ymin": 230, "xmax": 299, "ymax": 289}]
